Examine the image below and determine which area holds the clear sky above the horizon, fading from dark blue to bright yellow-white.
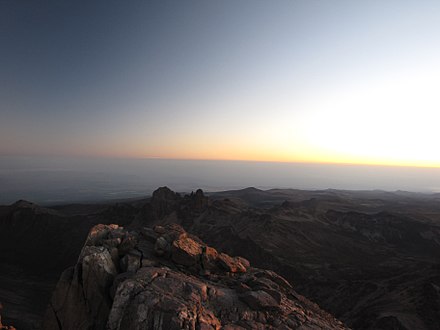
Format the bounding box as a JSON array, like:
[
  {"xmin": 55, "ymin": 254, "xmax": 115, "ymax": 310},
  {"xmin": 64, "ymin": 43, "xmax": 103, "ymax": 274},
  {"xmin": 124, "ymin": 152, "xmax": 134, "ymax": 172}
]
[{"xmin": 0, "ymin": 0, "xmax": 440, "ymax": 167}]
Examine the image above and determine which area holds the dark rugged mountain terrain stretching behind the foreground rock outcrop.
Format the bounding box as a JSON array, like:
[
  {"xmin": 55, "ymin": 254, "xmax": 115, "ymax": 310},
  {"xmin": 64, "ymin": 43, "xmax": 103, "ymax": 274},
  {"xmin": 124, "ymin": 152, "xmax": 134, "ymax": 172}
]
[{"xmin": 0, "ymin": 187, "xmax": 440, "ymax": 329}]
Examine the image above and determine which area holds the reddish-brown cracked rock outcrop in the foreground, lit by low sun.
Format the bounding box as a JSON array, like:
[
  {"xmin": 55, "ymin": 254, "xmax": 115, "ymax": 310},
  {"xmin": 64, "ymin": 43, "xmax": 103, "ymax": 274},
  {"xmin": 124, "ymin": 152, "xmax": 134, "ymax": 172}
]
[{"xmin": 43, "ymin": 224, "xmax": 345, "ymax": 330}]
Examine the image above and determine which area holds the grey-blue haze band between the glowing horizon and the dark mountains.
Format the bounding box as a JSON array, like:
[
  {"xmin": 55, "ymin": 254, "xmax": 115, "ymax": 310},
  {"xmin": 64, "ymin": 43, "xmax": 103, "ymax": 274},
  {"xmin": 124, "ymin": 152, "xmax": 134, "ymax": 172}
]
[{"xmin": 0, "ymin": 157, "xmax": 440, "ymax": 204}]
